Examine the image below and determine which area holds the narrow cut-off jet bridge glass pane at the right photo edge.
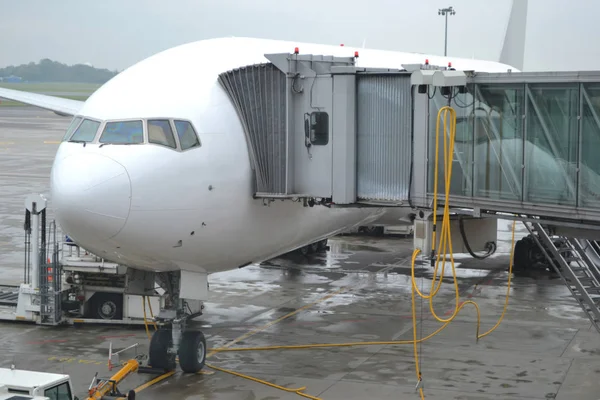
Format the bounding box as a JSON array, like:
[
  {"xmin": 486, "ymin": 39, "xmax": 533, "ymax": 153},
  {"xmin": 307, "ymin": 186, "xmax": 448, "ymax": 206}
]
[{"xmin": 579, "ymin": 84, "xmax": 600, "ymax": 207}]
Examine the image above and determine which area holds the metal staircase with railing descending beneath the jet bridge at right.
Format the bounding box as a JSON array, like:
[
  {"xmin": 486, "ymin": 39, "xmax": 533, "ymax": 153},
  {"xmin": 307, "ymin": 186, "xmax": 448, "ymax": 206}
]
[{"xmin": 523, "ymin": 222, "xmax": 600, "ymax": 333}]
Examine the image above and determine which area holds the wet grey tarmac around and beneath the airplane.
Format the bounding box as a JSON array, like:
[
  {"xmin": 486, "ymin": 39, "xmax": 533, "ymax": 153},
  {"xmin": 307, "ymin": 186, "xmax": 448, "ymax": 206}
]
[{"xmin": 0, "ymin": 107, "xmax": 600, "ymax": 400}]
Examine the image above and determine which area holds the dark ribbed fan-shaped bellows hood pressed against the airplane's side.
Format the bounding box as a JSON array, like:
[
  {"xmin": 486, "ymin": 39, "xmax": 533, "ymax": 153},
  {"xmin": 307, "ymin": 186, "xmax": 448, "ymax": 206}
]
[{"xmin": 219, "ymin": 63, "xmax": 287, "ymax": 193}]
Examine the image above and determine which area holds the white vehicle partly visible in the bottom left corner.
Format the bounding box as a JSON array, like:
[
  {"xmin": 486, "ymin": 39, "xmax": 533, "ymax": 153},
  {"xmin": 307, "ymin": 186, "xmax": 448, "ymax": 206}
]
[{"xmin": 0, "ymin": 368, "xmax": 79, "ymax": 400}]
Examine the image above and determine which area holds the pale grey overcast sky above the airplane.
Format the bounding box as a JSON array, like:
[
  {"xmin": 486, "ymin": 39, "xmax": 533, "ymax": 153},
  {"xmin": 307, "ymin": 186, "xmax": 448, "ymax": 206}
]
[{"xmin": 0, "ymin": 0, "xmax": 600, "ymax": 70}]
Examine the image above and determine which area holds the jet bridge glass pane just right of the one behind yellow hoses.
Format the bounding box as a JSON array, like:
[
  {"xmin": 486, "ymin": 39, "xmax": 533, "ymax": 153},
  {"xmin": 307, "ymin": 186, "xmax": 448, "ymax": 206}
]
[{"xmin": 470, "ymin": 85, "xmax": 525, "ymax": 200}]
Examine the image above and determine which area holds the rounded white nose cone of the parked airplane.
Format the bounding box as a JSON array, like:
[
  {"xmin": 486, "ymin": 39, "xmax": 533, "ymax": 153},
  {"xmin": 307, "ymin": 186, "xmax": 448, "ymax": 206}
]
[{"xmin": 50, "ymin": 153, "xmax": 131, "ymax": 241}]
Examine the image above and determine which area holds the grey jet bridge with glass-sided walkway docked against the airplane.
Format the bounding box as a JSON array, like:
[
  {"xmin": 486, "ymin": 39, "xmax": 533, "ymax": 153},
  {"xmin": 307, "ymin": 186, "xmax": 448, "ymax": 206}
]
[{"xmin": 220, "ymin": 54, "xmax": 600, "ymax": 222}]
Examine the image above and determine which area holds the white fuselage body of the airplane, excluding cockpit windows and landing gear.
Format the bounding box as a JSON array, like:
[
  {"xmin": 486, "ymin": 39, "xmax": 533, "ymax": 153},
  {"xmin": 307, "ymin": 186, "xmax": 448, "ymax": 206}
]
[{"xmin": 51, "ymin": 38, "xmax": 511, "ymax": 273}]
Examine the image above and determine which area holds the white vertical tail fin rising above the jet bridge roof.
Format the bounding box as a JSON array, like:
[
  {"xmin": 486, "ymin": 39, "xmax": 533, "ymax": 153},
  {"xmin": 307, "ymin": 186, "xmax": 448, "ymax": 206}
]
[{"xmin": 499, "ymin": 0, "xmax": 528, "ymax": 70}]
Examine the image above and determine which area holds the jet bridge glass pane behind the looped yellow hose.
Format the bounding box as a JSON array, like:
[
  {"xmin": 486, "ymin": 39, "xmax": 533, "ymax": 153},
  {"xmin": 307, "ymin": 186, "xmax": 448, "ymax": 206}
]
[{"xmin": 428, "ymin": 90, "xmax": 473, "ymax": 196}]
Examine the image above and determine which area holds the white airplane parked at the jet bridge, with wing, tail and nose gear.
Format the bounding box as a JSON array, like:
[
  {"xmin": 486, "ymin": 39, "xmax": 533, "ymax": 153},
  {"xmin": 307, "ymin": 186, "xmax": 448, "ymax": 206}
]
[{"xmin": 0, "ymin": 0, "xmax": 527, "ymax": 373}]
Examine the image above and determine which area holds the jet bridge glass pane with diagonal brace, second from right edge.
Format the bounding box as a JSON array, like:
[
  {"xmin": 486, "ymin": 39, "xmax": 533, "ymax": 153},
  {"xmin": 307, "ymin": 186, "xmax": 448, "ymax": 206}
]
[{"xmin": 524, "ymin": 84, "xmax": 579, "ymax": 205}]
